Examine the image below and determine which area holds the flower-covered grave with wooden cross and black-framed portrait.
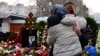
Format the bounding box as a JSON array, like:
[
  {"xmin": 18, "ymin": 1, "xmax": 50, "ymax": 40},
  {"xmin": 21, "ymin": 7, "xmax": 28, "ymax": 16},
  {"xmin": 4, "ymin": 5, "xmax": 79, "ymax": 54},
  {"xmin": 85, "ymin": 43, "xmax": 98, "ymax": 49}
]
[{"xmin": 0, "ymin": 13, "xmax": 49, "ymax": 56}]
